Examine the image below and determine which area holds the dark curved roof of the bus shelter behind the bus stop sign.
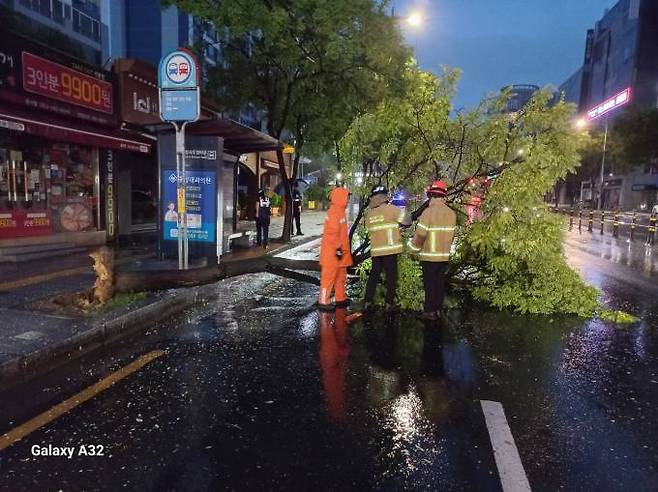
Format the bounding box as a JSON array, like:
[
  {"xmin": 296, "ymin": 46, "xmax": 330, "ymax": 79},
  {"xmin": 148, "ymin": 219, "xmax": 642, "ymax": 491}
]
[{"xmin": 149, "ymin": 119, "xmax": 284, "ymax": 155}]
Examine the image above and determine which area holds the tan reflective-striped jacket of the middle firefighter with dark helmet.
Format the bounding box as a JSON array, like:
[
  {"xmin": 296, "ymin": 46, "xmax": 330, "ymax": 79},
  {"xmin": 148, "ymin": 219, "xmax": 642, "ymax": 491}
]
[{"xmin": 366, "ymin": 203, "xmax": 406, "ymax": 256}]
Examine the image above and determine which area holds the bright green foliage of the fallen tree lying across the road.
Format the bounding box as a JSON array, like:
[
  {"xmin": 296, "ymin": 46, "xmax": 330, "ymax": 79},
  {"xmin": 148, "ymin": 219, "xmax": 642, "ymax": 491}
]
[{"xmin": 341, "ymin": 65, "xmax": 597, "ymax": 316}]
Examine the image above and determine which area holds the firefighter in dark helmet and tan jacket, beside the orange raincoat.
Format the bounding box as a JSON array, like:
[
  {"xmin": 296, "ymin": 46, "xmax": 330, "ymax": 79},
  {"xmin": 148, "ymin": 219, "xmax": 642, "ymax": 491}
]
[{"xmin": 364, "ymin": 186, "xmax": 411, "ymax": 310}]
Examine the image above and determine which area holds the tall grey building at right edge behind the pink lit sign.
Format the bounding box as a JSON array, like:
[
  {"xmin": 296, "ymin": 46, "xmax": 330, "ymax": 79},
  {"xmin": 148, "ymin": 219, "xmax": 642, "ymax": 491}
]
[{"xmin": 558, "ymin": 0, "xmax": 658, "ymax": 210}]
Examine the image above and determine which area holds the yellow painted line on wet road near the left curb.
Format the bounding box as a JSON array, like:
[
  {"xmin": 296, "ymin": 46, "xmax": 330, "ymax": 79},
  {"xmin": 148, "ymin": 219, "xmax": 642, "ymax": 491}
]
[{"xmin": 0, "ymin": 350, "xmax": 164, "ymax": 451}]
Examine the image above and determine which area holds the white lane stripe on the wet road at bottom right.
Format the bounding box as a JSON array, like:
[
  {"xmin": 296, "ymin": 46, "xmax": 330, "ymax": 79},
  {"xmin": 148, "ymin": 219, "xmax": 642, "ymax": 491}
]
[{"xmin": 480, "ymin": 400, "xmax": 531, "ymax": 492}]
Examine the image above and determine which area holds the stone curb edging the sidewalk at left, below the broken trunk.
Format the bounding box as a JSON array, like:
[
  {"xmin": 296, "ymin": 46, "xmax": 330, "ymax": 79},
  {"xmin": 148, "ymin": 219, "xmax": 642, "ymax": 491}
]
[{"xmin": 0, "ymin": 287, "xmax": 210, "ymax": 390}]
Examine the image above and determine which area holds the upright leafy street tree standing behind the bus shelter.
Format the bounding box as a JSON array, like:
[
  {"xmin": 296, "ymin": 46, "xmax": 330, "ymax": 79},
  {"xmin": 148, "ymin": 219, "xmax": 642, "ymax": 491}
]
[{"xmin": 163, "ymin": 0, "xmax": 410, "ymax": 240}]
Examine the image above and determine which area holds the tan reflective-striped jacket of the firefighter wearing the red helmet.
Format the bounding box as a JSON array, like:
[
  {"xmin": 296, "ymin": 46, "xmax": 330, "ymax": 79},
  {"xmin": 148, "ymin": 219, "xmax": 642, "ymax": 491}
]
[{"xmin": 409, "ymin": 198, "xmax": 457, "ymax": 262}]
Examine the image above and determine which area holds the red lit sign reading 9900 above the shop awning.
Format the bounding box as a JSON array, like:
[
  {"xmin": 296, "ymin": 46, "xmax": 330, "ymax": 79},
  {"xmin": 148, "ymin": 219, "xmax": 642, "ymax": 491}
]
[{"xmin": 23, "ymin": 51, "xmax": 114, "ymax": 114}]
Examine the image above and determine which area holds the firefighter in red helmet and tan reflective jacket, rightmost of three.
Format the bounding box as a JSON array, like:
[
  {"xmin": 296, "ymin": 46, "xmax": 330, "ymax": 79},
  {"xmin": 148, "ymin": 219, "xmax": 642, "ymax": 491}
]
[{"xmin": 409, "ymin": 181, "xmax": 457, "ymax": 320}]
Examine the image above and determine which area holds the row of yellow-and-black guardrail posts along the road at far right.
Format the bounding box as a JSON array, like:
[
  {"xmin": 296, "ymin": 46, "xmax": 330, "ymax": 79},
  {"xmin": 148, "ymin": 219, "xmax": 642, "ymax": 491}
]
[{"xmin": 555, "ymin": 208, "xmax": 658, "ymax": 245}]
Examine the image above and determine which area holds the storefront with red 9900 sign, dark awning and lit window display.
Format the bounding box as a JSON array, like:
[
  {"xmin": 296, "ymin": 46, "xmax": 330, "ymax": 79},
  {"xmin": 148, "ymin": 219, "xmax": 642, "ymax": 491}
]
[{"xmin": 0, "ymin": 37, "xmax": 153, "ymax": 250}]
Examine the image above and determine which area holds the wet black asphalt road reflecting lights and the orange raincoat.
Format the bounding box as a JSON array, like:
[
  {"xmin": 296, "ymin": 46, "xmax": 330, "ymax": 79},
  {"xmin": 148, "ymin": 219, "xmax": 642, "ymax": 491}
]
[{"xmin": 0, "ymin": 237, "xmax": 658, "ymax": 491}]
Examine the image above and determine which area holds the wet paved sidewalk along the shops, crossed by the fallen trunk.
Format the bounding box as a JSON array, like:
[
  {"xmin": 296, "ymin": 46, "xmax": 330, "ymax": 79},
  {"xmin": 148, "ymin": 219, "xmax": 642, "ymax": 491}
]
[{"xmin": 0, "ymin": 212, "xmax": 324, "ymax": 389}]
